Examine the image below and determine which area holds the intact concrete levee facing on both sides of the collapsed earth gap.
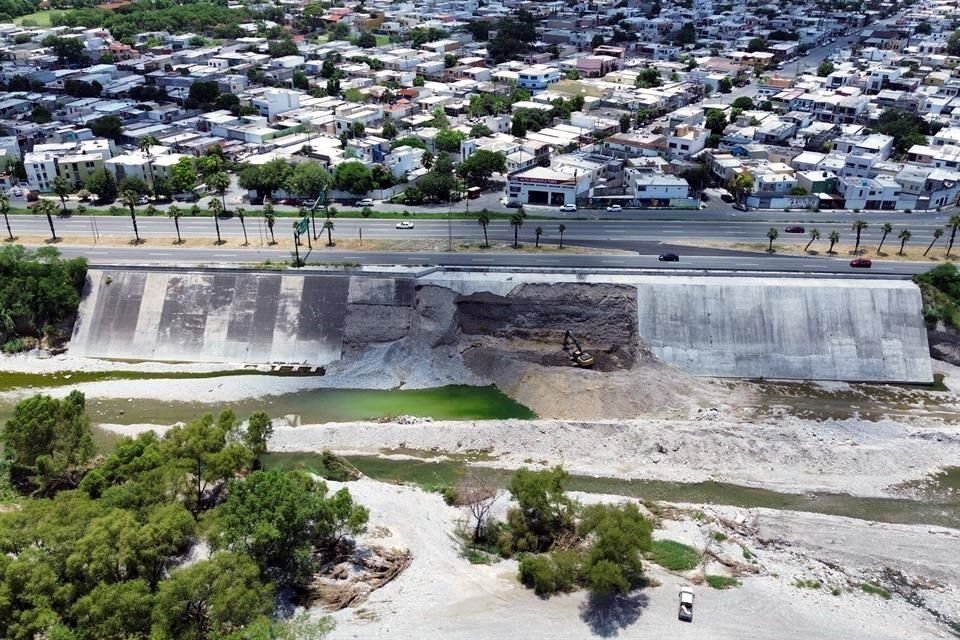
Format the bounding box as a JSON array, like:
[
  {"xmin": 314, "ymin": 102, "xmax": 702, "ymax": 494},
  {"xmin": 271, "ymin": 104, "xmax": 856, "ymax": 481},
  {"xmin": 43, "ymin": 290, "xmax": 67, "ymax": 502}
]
[{"xmin": 70, "ymin": 269, "xmax": 932, "ymax": 383}]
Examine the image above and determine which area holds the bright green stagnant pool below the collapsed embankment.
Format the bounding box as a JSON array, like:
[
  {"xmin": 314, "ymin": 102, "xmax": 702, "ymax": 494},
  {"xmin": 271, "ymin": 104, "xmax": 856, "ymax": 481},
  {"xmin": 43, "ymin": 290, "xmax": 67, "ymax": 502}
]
[{"xmin": 0, "ymin": 385, "xmax": 536, "ymax": 424}]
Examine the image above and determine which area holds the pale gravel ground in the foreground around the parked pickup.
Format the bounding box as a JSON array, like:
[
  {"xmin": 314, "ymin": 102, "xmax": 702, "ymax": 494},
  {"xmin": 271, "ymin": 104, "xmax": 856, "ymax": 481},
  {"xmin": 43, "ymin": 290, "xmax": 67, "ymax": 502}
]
[{"xmin": 320, "ymin": 480, "xmax": 953, "ymax": 640}]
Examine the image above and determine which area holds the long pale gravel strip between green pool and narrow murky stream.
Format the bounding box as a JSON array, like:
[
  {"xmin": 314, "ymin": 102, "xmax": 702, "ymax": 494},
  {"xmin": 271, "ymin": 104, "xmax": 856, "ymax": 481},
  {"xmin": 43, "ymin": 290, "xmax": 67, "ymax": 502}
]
[{"xmin": 258, "ymin": 412, "xmax": 960, "ymax": 496}]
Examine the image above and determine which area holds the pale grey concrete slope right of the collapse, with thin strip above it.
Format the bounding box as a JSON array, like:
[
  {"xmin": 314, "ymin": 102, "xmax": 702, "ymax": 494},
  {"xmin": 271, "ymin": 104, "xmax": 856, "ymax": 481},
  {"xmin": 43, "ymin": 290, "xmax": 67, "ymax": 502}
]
[{"xmin": 426, "ymin": 272, "xmax": 933, "ymax": 383}]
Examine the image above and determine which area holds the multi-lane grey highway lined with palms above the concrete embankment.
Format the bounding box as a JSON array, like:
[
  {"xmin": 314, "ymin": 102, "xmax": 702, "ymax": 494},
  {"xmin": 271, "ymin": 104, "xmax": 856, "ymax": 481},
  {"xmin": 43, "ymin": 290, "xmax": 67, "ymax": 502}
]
[{"xmin": 13, "ymin": 214, "xmax": 947, "ymax": 276}]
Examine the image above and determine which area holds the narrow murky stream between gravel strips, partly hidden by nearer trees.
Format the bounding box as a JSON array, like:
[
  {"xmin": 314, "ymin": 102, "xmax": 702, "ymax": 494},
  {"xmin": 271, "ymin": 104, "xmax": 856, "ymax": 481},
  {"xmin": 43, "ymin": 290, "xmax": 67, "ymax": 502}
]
[{"xmin": 264, "ymin": 452, "xmax": 960, "ymax": 528}]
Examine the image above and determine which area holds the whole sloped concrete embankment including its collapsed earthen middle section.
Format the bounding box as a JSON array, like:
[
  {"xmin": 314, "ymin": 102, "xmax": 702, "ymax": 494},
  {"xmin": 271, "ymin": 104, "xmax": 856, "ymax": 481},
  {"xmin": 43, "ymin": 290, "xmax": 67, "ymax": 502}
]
[{"xmin": 71, "ymin": 269, "xmax": 932, "ymax": 383}]
